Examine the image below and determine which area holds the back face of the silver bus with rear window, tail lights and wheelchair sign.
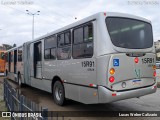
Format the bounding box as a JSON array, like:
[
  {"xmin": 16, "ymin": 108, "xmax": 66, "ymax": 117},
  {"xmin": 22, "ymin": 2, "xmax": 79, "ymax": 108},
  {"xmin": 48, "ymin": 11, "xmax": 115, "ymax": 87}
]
[{"xmin": 97, "ymin": 13, "xmax": 156, "ymax": 102}]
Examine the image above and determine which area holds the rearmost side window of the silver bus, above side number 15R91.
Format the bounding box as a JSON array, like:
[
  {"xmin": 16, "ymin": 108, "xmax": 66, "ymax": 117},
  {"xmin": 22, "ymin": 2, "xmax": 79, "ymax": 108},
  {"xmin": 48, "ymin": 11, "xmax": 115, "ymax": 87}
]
[{"xmin": 72, "ymin": 24, "xmax": 93, "ymax": 59}]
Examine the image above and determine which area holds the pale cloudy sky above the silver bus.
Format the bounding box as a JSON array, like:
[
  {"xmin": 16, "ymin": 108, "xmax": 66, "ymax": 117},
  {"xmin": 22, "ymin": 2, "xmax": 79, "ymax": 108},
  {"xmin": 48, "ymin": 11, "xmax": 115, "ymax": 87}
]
[{"xmin": 0, "ymin": 0, "xmax": 160, "ymax": 46}]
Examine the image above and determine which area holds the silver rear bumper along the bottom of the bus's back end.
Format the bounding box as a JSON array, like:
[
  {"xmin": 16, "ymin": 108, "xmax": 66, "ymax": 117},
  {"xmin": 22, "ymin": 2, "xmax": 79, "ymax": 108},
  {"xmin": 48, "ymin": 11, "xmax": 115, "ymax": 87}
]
[{"xmin": 98, "ymin": 84, "xmax": 157, "ymax": 103}]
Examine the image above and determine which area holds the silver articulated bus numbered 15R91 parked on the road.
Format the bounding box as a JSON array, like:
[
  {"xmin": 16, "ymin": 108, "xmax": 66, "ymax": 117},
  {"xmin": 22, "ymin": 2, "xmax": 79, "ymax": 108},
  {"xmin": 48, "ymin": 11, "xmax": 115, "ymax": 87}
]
[{"xmin": 6, "ymin": 12, "xmax": 157, "ymax": 105}]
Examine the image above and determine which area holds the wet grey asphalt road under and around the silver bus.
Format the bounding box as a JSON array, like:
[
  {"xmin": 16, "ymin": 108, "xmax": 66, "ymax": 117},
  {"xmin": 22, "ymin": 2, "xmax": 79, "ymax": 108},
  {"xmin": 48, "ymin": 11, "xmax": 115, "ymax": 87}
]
[{"xmin": 0, "ymin": 74, "xmax": 160, "ymax": 120}]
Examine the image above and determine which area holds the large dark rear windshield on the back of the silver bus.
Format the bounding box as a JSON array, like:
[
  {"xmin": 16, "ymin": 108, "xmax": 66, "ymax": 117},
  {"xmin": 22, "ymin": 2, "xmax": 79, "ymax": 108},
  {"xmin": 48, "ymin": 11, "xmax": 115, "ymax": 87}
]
[{"xmin": 106, "ymin": 17, "xmax": 153, "ymax": 49}]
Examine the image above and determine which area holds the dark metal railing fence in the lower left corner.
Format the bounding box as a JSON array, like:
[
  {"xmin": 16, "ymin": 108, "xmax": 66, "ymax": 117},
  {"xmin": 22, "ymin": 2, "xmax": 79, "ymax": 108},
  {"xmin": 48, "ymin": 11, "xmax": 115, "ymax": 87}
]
[{"xmin": 3, "ymin": 79, "xmax": 48, "ymax": 120}]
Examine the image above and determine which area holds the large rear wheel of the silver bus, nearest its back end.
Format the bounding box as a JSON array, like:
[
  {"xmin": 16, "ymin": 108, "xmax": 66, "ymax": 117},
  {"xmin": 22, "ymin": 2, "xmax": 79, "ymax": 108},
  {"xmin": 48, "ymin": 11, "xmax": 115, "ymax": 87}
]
[{"xmin": 53, "ymin": 81, "xmax": 65, "ymax": 106}]
